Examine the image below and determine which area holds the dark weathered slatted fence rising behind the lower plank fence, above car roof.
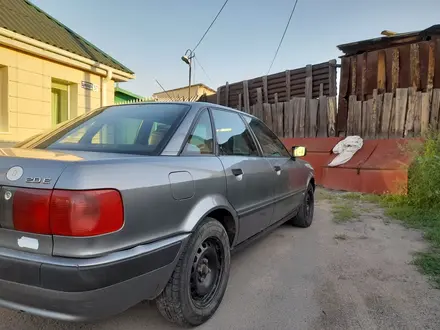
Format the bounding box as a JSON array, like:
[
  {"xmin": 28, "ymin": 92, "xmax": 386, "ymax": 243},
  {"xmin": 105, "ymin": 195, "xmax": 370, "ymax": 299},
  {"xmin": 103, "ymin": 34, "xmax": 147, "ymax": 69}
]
[{"xmin": 207, "ymin": 60, "xmax": 337, "ymax": 110}]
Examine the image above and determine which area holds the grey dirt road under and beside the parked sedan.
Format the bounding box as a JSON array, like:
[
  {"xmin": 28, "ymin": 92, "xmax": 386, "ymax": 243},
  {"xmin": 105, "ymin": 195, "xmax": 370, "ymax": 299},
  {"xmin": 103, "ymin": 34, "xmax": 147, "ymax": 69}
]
[{"xmin": 0, "ymin": 189, "xmax": 440, "ymax": 330}]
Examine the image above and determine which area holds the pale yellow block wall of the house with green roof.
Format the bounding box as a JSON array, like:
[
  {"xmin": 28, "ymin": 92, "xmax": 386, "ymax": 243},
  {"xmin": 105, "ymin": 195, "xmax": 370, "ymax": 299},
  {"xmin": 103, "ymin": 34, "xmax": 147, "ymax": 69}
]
[{"xmin": 0, "ymin": 45, "xmax": 114, "ymax": 141}]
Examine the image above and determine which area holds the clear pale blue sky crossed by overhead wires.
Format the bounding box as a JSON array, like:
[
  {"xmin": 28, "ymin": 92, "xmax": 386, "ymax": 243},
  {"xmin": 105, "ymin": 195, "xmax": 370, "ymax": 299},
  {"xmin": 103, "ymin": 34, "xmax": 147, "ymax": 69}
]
[{"xmin": 31, "ymin": 0, "xmax": 440, "ymax": 97}]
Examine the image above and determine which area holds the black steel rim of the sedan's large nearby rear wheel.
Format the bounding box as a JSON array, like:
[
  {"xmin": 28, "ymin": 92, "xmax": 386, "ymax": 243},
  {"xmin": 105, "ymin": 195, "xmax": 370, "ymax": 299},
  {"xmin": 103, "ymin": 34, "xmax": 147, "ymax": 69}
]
[{"xmin": 190, "ymin": 237, "xmax": 225, "ymax": 308}]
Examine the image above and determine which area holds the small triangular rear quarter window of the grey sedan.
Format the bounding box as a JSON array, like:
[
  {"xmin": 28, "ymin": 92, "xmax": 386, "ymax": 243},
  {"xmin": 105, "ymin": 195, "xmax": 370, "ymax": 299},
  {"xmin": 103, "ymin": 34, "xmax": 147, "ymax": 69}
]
[{"xmin": 182, "ymin": 110, "xmax": 214, "ymax": 155}]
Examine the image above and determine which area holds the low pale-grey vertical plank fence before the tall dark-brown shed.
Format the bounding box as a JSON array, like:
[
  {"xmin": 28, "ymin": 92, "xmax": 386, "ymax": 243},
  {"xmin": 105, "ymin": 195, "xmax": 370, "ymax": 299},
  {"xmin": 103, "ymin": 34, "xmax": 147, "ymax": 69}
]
[{"xmin": 347, "ymin": 87, "xmax": 440, "ymax": 139}]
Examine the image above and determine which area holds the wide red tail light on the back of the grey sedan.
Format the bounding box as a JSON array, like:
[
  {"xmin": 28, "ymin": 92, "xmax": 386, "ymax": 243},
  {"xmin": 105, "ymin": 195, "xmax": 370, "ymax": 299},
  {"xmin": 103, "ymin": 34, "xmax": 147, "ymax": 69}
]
[{"xmin": 12, "ymin": 189, "xmax": 124, "ymax": 236}]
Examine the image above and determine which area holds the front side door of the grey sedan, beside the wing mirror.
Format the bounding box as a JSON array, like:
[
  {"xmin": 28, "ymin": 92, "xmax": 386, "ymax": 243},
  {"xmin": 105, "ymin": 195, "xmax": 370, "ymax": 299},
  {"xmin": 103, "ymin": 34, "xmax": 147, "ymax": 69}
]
[{"xmin": 245, "ymin": 116, "xmax": 303, "ymax": 223}]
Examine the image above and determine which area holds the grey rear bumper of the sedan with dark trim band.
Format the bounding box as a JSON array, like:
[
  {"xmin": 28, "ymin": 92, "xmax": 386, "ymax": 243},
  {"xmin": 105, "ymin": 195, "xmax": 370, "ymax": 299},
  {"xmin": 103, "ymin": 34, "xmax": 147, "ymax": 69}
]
[{"xmin": 0, "ymin": 235, "xmax": 188, "ymax": 321}]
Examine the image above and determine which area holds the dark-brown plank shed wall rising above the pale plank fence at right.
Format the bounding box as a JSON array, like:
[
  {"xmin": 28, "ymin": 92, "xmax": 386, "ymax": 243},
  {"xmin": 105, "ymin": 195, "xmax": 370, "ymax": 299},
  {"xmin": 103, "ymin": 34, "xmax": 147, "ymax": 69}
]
[{"xmin": 337, "ymin": 36, "xmax": 440, "ymax": 133}]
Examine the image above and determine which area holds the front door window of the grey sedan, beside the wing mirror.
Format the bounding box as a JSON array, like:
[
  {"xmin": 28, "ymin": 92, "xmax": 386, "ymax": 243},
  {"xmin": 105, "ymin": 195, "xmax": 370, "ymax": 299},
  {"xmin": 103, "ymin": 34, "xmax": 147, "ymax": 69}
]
[{"xmin": 244, "ymin": 116, "xmax": 290, "ymax": 157}]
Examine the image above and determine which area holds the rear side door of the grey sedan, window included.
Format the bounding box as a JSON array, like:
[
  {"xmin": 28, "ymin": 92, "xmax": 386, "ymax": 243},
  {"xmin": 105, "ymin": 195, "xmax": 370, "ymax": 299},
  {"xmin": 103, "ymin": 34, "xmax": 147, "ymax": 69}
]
[{"xmin": 212, "ymin": 109, "xmax": 274, "ymax": 243}]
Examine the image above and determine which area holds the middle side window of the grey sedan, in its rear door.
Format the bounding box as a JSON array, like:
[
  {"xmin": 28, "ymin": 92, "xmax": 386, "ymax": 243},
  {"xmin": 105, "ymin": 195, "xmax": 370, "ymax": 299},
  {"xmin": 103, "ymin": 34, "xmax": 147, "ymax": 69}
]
[{"xmin": 212, "ymin": 110, "xmax": 258, "ymax": 156}]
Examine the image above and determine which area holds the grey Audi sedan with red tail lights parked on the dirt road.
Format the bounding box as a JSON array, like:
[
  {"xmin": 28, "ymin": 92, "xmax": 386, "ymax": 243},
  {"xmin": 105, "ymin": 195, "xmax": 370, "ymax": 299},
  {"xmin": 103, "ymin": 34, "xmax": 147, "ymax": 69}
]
[{"xmin": 0, "ymin": 103, "xmax": 315, "ymax": 326}]
